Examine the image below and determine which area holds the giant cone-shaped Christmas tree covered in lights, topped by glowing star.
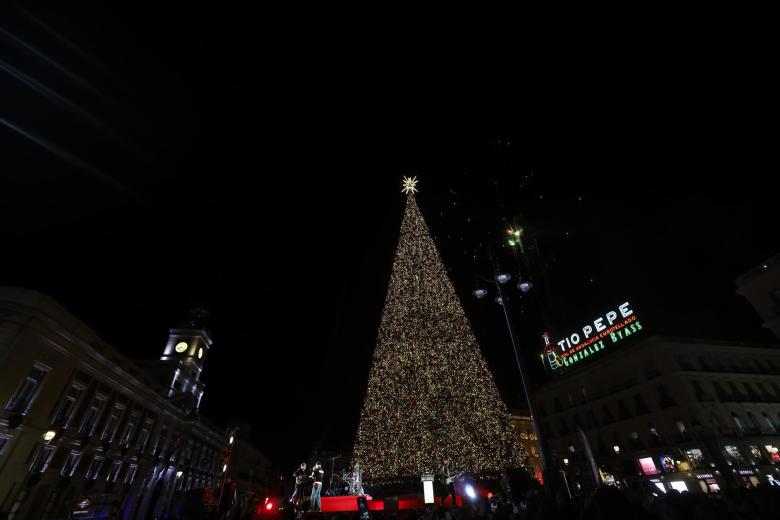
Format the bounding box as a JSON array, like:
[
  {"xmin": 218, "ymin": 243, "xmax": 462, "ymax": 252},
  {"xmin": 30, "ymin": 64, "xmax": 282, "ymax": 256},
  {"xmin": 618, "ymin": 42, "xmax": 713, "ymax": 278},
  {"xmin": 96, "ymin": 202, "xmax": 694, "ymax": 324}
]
[{"xmin": 354, "ymin": 178, "xmax": 527, "ymax": 481}]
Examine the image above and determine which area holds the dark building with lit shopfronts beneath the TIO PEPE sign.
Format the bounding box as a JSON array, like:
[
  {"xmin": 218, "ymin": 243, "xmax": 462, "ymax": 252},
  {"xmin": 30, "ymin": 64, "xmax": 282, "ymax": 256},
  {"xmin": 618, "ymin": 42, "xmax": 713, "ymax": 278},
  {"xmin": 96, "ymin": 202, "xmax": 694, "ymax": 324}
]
[{"xmin": 536, "ymin": 336, "xmax": 780, "ymax": 493}]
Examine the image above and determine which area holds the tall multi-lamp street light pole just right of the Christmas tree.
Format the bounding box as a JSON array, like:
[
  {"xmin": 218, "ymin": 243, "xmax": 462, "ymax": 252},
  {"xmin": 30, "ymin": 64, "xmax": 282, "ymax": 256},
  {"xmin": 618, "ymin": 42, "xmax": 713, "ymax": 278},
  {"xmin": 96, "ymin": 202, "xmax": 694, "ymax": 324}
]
[{"xmin": 472, "ymin": 254, "xmax": 552, "ymax": 482}]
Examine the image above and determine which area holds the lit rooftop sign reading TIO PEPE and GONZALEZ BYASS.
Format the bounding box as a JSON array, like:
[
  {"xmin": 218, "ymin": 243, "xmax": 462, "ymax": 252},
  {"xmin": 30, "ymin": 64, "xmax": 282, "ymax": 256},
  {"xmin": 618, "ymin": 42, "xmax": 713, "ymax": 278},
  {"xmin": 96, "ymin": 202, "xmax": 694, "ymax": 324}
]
[{"xmin": 542, "ymin": 302, "xmax": 643, "ymax": 370}]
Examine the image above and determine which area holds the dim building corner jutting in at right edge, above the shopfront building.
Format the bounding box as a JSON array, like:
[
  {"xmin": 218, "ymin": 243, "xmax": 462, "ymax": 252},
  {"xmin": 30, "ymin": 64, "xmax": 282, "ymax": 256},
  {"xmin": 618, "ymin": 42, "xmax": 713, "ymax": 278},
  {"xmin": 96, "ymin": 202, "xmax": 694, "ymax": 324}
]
[{"xmin": 736, "ymin": 254, "xmax": 780, "ymax": 339}]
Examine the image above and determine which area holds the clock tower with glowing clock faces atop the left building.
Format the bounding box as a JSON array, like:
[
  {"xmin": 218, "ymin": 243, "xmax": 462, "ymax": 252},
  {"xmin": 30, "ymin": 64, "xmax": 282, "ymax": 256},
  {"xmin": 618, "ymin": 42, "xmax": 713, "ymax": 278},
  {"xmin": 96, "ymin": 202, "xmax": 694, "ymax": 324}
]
[{"xmin": 160, "ymin": 307, "xmax": 211, "ymax": 413}]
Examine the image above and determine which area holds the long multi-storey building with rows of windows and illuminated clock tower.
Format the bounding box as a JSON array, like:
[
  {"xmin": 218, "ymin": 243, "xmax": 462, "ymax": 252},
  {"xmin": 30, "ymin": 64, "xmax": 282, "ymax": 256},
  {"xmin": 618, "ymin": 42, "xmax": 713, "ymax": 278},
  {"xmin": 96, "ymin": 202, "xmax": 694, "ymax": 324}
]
[{"xmin": 0, "ymin": 288, "xmax": 228, "ymax": 520}]
